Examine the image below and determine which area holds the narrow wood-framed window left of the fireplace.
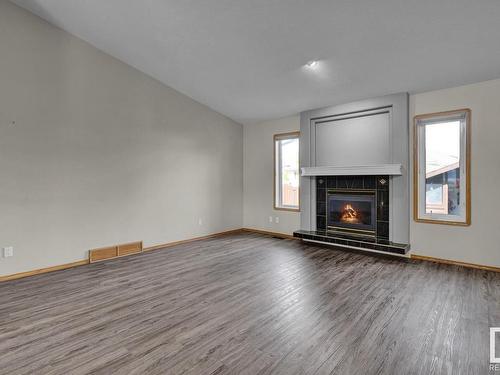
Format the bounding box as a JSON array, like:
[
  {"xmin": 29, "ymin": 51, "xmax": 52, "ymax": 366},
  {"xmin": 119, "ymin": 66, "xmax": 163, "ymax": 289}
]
[{"xmin": 274, "ymin": 132, "xmax": 300, "ymax": 211}]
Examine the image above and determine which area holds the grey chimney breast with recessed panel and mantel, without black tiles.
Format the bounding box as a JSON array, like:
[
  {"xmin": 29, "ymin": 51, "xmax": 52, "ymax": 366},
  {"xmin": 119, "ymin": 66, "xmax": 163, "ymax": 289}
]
[{"xmin": 300, "ymin": 93, "xmax": 410, "ymax": 244}]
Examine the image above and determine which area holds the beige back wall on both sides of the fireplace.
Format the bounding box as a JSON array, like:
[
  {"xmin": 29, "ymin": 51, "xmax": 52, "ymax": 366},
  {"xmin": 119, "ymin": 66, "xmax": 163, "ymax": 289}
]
[{"xmin": 243, "ymin": 80, "xmax": 500, "ymax": 267}]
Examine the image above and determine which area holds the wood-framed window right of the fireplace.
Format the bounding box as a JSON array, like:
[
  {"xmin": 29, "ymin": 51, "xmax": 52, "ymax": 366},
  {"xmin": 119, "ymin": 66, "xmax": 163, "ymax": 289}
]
[{"xmin": 414, "ymin": 109, "xmax": 470, "ymax": 225}]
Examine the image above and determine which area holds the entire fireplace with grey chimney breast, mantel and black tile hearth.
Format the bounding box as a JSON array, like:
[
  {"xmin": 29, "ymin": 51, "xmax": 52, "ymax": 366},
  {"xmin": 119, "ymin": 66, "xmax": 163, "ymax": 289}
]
[{"xmin": 294, "ymin": 93, "xmax": 410, "ymax": 254}]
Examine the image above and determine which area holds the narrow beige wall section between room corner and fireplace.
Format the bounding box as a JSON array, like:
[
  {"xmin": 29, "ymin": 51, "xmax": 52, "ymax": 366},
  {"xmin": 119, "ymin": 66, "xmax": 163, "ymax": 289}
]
[{"xmin": 243, "ymin": 115, "xmax": 300, "ymax": 234}]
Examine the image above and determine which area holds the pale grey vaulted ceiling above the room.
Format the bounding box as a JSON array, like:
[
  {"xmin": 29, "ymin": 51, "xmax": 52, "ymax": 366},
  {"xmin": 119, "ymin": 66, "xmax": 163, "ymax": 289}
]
[{"xmin": 9, "ymin": 0, "xmax": 500, "ymax": 123}]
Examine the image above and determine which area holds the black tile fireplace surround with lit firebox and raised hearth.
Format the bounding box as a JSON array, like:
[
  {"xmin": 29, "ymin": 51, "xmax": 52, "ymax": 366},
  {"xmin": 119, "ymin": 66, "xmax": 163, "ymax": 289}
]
[{"xmin": 294, "ymin": 175, "xmax": 409, "ymax": 254}]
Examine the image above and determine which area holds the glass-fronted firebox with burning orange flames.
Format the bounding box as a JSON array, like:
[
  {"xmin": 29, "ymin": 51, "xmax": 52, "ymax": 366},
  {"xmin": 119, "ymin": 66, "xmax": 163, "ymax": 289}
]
[{"xmin": 326, "ymin": 189, "xmax": 377, "ymax": 237}]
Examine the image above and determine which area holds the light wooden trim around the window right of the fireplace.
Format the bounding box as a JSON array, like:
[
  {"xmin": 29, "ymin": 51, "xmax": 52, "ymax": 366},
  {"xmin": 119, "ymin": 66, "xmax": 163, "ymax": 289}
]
[{"xmin": 413, "ymin": 108, "xmax": 472, "ymax": 226}]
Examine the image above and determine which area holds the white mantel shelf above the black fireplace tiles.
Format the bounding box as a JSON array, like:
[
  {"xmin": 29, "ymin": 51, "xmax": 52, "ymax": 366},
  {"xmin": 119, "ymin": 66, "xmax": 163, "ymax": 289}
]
[{"xmin": 301, "ymin": 164, "xmax": 403, "ymax": 177}]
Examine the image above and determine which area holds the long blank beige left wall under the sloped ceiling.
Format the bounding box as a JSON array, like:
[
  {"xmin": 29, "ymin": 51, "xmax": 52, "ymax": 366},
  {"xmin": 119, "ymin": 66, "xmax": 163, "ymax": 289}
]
[{"xmin": 0, "ymin": 0, "xmax": 243, "ymax": 275}]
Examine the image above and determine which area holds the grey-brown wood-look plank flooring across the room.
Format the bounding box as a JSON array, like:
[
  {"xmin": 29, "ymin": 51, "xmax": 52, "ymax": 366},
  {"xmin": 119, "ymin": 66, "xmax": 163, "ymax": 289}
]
[{"xmin": 0, "ymin": 234, "xmax": 500, "ymax": 375}]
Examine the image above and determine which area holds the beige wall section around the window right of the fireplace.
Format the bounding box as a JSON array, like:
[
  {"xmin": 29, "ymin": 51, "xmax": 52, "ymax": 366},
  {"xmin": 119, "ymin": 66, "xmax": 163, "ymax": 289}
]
[{"xmin": 410, "ymin": 80, "xmax": 500, "ymax": 267}]
